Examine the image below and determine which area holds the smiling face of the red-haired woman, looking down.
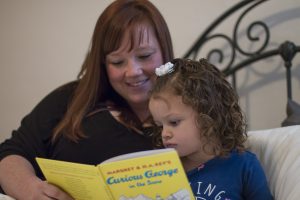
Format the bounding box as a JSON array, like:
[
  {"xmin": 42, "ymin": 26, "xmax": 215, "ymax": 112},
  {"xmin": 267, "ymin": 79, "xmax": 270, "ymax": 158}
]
[{"xmin": 106, "ymin": 26, "xmax": 163, "ymax": 111}]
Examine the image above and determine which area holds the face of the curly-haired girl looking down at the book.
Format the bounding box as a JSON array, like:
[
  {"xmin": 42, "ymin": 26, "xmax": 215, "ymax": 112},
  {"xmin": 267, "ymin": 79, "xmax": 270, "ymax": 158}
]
[{"xmin": 149, "ymin": 91, "xmax": 210, "ymax": 160}]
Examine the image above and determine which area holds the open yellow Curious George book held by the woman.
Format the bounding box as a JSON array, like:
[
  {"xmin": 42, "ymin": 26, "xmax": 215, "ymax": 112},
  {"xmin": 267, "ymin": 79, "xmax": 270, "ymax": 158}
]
[{"xmin": 36, "ymin": 148, "xmax": 194, "ymax": 200}]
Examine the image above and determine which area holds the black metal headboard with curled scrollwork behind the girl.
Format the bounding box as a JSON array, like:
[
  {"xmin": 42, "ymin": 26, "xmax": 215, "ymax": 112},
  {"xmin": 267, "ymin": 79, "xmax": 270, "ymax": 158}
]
[{"xmin": 183, "ymin": 0, "xmax": 300, "ymax": 126}]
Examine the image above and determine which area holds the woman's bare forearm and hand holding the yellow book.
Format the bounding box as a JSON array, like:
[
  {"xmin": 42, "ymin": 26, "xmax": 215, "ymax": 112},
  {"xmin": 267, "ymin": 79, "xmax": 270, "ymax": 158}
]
[{"xmin": 0, "ymin": 155, "xmax": 72, "ymax": 200}]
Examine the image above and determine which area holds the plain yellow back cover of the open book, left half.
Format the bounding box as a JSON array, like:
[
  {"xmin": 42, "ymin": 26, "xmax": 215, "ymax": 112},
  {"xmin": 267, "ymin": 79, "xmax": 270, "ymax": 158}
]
[{"xmin": 36, "ymin": 158, "xmax": 111, "ymax": 200}]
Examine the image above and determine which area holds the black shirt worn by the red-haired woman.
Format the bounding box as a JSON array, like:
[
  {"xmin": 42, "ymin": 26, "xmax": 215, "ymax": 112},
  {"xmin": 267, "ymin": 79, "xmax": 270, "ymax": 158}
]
[{"xmin": 0, "ymin": 82, "xmax": 152, "ymax": 179}]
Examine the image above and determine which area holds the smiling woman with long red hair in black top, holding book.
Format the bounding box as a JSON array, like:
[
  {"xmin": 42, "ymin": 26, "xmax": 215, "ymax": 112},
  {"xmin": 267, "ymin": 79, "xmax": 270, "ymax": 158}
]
[{"xmin": 0, "ymin": 0, "xmax": 173, "ymax": 200}]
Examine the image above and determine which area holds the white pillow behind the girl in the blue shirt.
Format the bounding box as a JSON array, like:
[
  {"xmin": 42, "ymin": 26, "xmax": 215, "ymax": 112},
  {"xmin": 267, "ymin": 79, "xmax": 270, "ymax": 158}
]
[{"xmin": 247, "ymin": 125, "xmax": 300, "ymax": 200}]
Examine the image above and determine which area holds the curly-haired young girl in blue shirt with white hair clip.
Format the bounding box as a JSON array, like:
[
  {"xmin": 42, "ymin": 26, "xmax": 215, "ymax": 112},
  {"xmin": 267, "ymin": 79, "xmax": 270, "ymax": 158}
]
[{"xmin": 149, "ymin": 59, "xmax": 273, "ymax": 200}]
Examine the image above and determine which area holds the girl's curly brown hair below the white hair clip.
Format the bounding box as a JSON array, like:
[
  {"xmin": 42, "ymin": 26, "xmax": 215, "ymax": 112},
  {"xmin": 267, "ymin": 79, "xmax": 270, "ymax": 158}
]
[{"xmin": 151, "ymin": 59, "xmax": 247, "ymax": 156}]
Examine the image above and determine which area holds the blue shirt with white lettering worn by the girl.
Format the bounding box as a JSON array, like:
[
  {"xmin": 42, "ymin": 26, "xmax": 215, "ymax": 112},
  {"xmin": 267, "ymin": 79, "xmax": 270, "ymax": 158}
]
[{"xmin": 187, "ymin": 151, "xmax": 273, "ymax": 200}]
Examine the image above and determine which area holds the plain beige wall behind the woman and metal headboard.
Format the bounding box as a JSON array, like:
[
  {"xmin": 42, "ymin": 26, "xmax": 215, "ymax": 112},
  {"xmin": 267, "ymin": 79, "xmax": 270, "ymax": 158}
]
[{"xmin": 0, "ymin": 0, "xmax": 300, "ymax": 141}]
